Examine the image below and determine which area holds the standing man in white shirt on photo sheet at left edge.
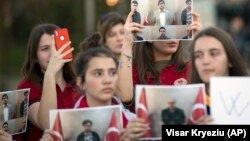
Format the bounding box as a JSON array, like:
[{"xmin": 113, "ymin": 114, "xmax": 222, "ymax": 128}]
[{"xmin": 0, "ymin": 94, "xmax": 13, "ymax": 121}]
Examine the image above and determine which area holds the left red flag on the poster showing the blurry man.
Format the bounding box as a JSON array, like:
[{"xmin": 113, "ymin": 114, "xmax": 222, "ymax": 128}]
[{"xmin": 136, "ymin": 88, "xmax": 152, "ymax": 138}]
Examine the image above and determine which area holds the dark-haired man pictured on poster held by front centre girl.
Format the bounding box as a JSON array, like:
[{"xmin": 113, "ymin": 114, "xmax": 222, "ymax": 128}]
[{"xmin": 77, "ymin": 120, "xmax": 100, "ymax": 141}]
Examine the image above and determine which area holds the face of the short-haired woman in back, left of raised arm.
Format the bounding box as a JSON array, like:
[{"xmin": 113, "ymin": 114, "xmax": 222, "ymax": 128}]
[{"xmin": 105, "ymin": 24, "xmax": 124, "ymax": 54}]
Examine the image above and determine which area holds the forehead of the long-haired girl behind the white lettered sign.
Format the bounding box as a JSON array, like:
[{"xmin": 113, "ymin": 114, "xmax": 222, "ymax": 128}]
[{"xmin": 194, "ymin": 36, "xmax": 225, "ymax": 52}]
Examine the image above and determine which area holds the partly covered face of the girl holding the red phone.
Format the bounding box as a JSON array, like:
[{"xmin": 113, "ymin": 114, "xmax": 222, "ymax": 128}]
[{"xmin": 36, "ymin": 33, "xmax": 52, "ymax": 73}]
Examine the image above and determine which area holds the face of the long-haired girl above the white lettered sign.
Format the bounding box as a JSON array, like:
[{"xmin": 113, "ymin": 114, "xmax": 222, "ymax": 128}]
[{"xmin": 194, "ymin": 36, "xmax": 232, "ymax": 84}]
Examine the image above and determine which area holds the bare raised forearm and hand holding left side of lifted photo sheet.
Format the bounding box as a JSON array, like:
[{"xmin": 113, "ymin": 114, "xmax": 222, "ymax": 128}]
[{"xmin": 116, "ymin": 11, "xmax": 144, "ymax": 102}]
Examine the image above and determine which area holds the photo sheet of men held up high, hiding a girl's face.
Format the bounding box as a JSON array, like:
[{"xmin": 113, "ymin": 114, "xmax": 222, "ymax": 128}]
[{"xmin": 131, "ymin": 0, "xmax": 193, "ymax": 42}]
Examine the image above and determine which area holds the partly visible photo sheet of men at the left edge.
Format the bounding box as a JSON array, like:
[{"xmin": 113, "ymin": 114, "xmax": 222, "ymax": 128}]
[{"xmin": 0, "ymin": 89, "xmax": 30, "ymax": 135}]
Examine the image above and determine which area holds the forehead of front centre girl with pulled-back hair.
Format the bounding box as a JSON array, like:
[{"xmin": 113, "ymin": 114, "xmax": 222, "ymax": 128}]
[{"xmin": 87, "ymin": 56, "xmax": 116, "ymax": 70}]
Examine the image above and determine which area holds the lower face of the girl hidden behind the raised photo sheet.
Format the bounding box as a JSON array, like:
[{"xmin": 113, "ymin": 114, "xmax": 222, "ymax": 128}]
[{"xmin": 152, "ymin": 40, "xmax": 180, "ymax": 61}]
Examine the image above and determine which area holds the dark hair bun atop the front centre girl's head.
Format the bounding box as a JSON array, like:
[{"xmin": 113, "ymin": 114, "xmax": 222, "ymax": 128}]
[{"xmin": 79, "ymin": 32, "xmax": 102, "ymax": 51}]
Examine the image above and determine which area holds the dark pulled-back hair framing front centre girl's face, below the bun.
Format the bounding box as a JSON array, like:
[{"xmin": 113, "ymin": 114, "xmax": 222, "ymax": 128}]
[{"xmin": 74, "ymin": 47, "xmax": 118, "ymax": 82}]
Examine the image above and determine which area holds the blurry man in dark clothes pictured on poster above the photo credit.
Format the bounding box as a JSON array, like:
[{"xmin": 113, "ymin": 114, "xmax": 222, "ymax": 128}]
[{"xmin": 161, "ymin": 98, "xmax": 186, "ymax": 125}]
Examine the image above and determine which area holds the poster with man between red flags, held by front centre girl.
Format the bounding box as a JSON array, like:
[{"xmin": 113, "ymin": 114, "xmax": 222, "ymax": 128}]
[{"xmin": 50, "ymin": 105, "xmax": 123, "ymax": 141}]
